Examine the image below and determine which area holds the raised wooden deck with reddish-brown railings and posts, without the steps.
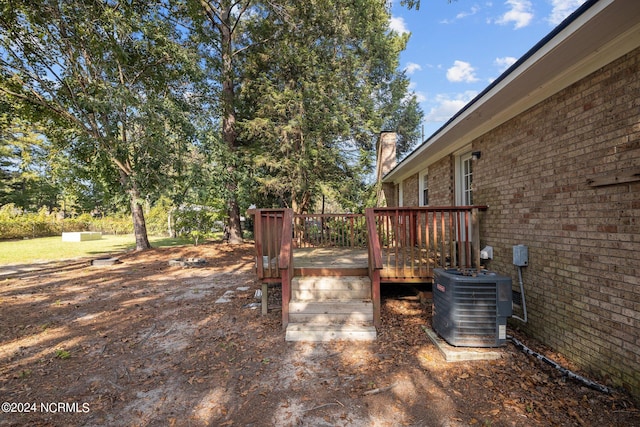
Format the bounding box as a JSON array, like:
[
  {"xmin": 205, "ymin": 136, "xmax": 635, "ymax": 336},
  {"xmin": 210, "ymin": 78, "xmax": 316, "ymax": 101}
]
[{"xmin": 249, "ymin": 206, "xmax": 487, "ymax": 327}]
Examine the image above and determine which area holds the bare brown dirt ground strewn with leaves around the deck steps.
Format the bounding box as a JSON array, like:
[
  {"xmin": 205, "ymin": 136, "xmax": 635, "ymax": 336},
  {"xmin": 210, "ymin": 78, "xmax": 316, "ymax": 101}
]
[{"xmin": 0, "ymin": 243, "xmax": 640, "ymax": 426}]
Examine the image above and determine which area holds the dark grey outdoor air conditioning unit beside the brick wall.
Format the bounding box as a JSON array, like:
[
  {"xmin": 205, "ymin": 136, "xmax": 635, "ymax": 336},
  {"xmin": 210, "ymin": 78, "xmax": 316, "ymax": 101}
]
[{"xmin": 433, "ymin": 268, "xmax": 512, "ymax": 347}]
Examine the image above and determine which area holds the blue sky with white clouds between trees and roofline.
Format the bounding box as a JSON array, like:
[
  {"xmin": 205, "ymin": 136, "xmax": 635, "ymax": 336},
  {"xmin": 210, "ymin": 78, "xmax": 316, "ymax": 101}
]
[{"xmin": 391, "ymin": 0, "xmax": 585, "ymax": 138}]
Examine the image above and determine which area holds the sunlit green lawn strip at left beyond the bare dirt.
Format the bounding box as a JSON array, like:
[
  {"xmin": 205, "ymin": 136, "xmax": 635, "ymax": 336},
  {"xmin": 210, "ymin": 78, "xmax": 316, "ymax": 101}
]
[{"xmin": 0, "ymin": 234, "xmax": 193, "ymax": 265}]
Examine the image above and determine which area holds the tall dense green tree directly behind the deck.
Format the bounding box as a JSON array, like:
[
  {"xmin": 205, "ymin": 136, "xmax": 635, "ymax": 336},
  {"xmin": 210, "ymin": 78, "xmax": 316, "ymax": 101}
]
[{"xmin": 239, "ymin": 0, "xmax": 421, "ymax": 212}]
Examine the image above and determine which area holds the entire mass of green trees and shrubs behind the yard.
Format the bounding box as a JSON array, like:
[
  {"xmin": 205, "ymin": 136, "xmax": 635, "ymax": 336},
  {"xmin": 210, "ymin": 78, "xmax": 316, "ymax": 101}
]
[{"xmin": 0, "ymin": 0, "xmax": 422, "ymax": 229}]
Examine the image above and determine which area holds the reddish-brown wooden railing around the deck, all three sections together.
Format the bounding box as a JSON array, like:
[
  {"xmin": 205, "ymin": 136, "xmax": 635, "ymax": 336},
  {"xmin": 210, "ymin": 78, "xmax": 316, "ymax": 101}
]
[{"xmin": 252, "ymin": 206, "xmax": 486, "ymax": 282}]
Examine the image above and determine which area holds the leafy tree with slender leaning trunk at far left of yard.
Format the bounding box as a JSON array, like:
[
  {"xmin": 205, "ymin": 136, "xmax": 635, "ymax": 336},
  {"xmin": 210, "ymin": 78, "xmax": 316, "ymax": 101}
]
[{"xmin": 0, "ymin": 0, "xmax": 199, "ymax": 249}]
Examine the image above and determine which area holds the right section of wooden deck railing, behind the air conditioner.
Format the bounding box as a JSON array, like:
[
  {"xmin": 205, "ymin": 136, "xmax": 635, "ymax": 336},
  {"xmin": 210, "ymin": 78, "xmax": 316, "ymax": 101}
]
[{"xmin": 374, "ymin": 206, "xmax": 486, "ymax": 282}]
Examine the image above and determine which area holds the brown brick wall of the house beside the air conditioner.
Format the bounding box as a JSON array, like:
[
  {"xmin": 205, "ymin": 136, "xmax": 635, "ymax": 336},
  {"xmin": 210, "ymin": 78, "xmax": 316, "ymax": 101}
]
[{"xmin": 476, "ymin": 49, "xmax": 640, "ymax": 396}]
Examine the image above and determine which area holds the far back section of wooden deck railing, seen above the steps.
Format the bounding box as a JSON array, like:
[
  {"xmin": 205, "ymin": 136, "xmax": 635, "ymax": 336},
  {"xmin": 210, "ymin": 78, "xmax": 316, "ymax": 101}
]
[{"xmin": 294, "ymin": 214, "xmax": 367, "ymax": 249}]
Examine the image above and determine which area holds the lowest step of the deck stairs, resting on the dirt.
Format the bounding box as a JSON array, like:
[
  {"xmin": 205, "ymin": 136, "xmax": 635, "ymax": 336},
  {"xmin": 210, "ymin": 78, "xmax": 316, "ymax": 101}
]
[{"xmin": 285, "ymin": 323, "xmax": 376, "ymax": 342}]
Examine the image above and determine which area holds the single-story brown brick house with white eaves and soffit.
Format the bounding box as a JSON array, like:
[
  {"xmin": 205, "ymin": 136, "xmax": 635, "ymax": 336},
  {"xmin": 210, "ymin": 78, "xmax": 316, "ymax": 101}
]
[{"xmin": 381, "ymin": 0, "xmax": 640, "ymax": 397}]
